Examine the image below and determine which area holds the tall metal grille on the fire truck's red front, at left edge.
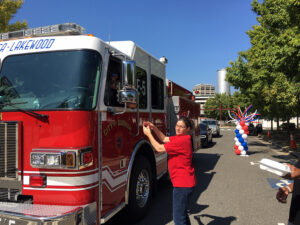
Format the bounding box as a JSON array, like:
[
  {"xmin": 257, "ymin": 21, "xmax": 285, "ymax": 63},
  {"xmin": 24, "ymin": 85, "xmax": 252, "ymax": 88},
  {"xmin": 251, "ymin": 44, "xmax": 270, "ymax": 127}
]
[{"xmin": 0, "ymin": 122, "xmax": 19, "ymax": 179}]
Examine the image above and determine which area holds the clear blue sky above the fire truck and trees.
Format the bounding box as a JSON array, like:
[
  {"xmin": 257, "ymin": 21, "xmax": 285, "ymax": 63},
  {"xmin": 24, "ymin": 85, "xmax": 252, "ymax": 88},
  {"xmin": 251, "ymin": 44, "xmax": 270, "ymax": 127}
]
[{"xmin": 11, "ymin": 0, "xmax": 257, "ymax": 90}]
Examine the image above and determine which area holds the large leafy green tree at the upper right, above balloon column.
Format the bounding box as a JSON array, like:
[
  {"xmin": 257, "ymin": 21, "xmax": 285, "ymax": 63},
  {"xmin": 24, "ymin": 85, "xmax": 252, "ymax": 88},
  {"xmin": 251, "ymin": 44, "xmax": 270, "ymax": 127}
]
[{"xmin": 227, "ymin": 0, "xmax": 300, "ymax": 125}]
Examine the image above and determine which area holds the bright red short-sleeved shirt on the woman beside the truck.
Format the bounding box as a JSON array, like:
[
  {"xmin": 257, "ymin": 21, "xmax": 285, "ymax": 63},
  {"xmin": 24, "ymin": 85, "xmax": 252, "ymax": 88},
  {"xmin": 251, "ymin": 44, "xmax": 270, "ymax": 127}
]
[{"xmin": 164, "ymin": 135, "xmax": 196, "ymax": 187}]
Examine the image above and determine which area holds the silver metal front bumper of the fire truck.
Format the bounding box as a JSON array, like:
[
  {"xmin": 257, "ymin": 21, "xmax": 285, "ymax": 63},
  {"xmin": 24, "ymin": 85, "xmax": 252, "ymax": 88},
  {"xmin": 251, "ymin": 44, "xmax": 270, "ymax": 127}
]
[{"xmin": 0, "ymin": 202, "xmax": 97, "ymax": 225}]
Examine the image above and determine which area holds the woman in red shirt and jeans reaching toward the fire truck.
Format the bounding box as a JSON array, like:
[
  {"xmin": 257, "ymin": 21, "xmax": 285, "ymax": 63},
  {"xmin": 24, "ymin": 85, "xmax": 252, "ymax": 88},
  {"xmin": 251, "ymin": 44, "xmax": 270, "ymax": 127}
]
[{"xmin": 143, "ymin": 117, "xmax": 196, "ymax": 225}]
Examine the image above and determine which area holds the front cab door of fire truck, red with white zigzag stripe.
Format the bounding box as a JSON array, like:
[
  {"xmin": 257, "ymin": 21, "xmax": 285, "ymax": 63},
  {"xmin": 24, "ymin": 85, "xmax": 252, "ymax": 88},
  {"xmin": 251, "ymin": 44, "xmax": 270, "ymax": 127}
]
[{"xmin": 101, "ymin": 56, "xmax": 137, "ymax": 216}]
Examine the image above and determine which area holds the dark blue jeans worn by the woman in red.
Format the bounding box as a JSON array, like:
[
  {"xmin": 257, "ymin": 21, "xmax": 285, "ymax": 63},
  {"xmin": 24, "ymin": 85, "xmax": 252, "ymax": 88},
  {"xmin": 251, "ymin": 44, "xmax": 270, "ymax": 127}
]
[{"xmin": 173, "ymin": 187, "xmax": 194, "ymax": 225}]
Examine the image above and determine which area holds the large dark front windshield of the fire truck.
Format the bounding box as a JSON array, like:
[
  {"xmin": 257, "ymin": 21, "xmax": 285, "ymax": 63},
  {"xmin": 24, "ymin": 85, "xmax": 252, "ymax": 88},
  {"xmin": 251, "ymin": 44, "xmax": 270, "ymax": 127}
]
[{"xmin": 0, "ymin": 50, "xmax": 101, "ymax": 111}]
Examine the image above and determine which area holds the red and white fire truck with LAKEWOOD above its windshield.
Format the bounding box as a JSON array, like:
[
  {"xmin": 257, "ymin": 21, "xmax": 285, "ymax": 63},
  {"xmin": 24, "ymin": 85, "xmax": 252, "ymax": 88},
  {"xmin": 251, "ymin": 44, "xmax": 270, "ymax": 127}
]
[{"xmin": 0, "ymin": 23, "xmax": 200, "ymax": 225}]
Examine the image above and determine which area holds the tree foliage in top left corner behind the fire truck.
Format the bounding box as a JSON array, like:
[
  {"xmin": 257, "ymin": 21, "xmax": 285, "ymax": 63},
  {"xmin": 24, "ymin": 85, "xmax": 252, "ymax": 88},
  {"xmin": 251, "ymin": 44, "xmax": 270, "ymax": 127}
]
[{"xmin": 0, "ymin": 0, "xmax": 27, "ymax": 33}]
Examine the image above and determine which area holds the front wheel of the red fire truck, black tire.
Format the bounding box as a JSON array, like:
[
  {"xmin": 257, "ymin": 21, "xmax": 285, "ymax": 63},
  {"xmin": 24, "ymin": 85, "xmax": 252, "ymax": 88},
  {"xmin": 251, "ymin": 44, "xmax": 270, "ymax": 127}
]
[{"xmin": 128, "ymin": 156, "xmax": 153, "ymax": 221}]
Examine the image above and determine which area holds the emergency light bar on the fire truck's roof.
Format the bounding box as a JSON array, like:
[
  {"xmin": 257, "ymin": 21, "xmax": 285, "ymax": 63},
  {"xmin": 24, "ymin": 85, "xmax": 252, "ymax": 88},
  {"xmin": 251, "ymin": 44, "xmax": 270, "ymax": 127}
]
[{"xmin": 0, "ymin": 23, "xmax": 85, "ymax": 40}]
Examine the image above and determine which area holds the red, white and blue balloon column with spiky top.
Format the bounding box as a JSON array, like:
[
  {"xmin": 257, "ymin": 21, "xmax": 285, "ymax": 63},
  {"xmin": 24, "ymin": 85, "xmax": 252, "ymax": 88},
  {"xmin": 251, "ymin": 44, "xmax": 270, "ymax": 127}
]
[{"xmin": 228, "ymin": 105, "xmax": 259, "ymax": 156}]
